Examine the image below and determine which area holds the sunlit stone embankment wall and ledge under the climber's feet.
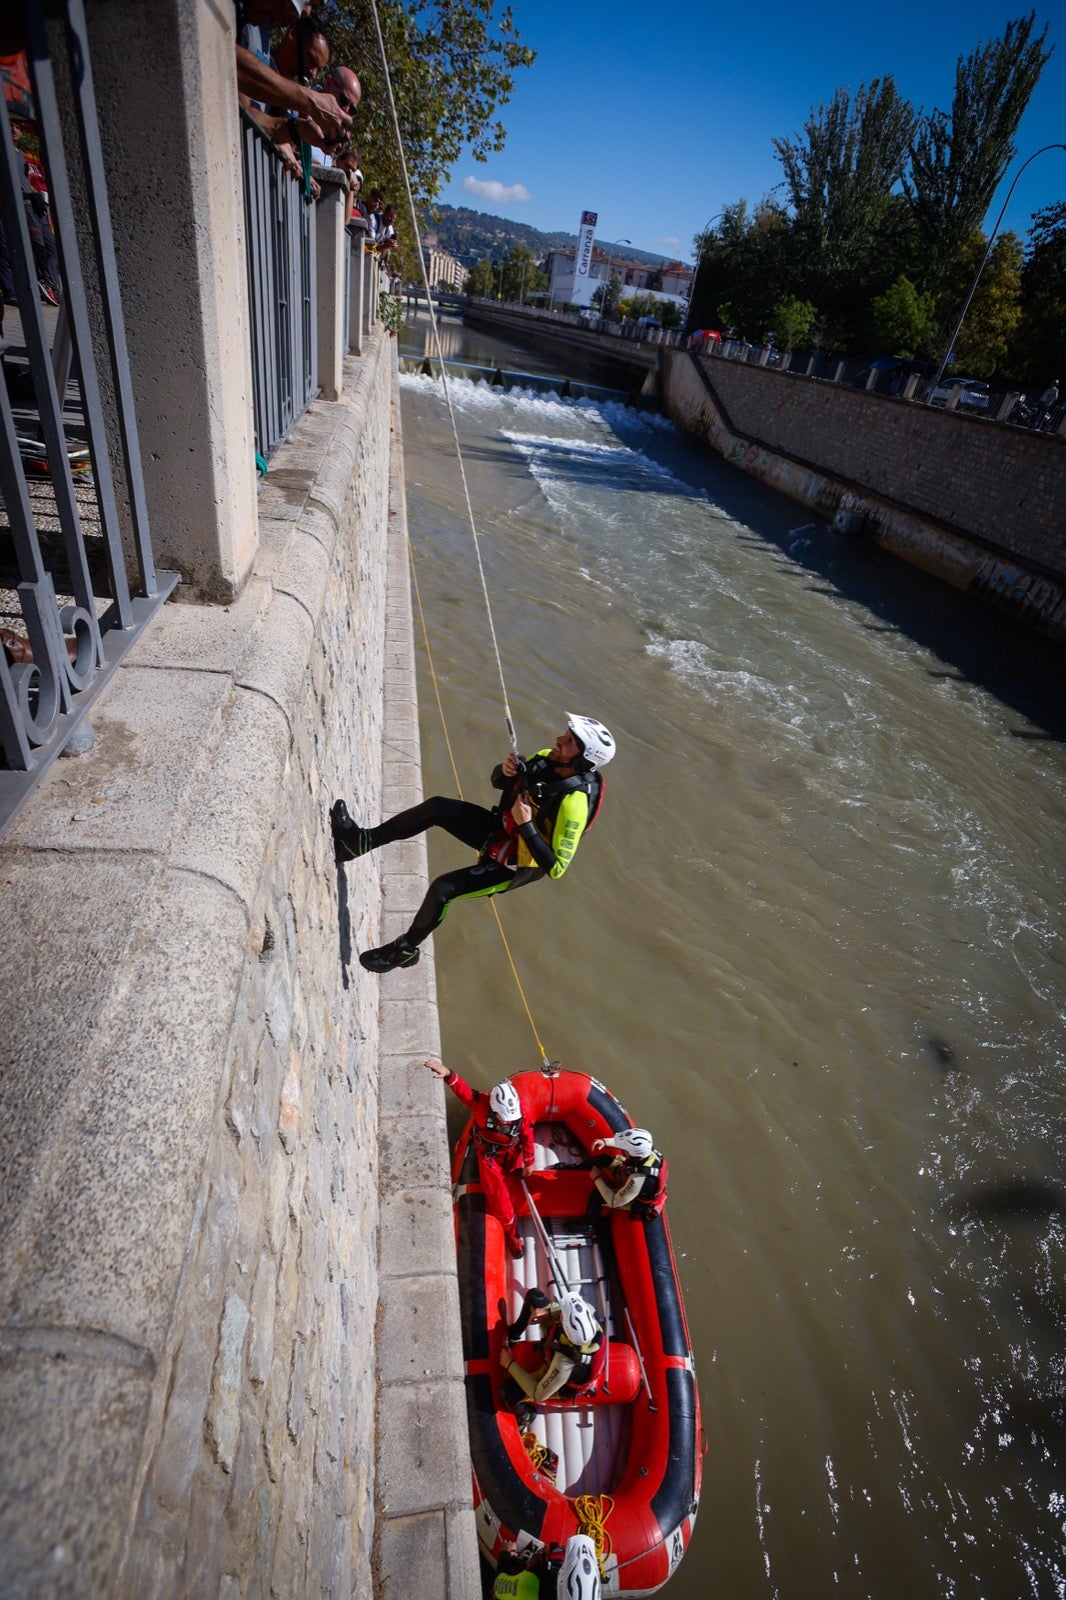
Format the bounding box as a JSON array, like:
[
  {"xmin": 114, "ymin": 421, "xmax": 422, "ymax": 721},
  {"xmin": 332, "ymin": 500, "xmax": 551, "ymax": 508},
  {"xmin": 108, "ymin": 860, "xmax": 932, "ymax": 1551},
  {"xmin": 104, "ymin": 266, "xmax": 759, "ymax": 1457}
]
[{"xmin": 0, "ymin": 336, "xmax": 477, "ymax": 1600}]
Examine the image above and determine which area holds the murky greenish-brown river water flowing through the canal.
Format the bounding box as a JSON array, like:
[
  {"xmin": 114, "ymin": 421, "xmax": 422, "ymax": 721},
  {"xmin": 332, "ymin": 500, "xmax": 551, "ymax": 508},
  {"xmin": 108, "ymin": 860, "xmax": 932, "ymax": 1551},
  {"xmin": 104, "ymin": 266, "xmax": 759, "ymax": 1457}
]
[{"xmin": 392, "ymin": 305, "xmax": 1066, "ymax": 1600}]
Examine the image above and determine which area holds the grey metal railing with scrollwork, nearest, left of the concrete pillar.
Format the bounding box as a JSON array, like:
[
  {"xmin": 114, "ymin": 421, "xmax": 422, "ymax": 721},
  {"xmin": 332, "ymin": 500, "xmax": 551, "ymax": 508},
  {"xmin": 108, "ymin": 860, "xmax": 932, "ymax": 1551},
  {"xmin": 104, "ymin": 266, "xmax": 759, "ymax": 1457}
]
[{"xmin": 0, "ymin": 0, "xmax": 178, "ymax": 829}]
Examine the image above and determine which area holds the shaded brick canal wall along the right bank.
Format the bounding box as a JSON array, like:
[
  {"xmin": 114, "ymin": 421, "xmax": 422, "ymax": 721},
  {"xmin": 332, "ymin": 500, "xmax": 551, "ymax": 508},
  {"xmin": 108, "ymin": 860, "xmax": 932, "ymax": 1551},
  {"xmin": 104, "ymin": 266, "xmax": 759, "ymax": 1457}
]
[{"xmin": 653, "ymin": 349, "xmax": 1066, "ymax": 642}]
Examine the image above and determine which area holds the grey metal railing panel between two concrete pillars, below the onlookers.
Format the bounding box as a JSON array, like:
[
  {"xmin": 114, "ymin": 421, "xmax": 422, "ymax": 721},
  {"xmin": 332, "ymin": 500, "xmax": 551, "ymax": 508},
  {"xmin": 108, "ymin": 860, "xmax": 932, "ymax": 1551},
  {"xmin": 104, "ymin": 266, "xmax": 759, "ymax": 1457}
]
[{"xmin": 240, "ymin": 110, "xmax": 319, "ymax": 459}]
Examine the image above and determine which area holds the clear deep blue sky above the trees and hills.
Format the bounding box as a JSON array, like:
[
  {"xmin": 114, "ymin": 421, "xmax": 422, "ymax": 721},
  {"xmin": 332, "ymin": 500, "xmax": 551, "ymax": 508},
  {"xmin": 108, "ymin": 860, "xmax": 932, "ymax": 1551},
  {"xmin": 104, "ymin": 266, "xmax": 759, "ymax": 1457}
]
[{"xmin": 440, "ymin": 0, "xmax": 1066, "ymax": 259}]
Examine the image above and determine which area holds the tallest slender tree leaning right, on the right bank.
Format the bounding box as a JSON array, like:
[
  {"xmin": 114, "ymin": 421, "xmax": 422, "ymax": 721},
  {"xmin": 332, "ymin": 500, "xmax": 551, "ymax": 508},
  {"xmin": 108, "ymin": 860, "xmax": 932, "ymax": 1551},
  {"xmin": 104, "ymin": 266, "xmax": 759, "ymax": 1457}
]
[{"xmin": 906, "ymin": 11, "xmax": 1052, "ymax": 292}]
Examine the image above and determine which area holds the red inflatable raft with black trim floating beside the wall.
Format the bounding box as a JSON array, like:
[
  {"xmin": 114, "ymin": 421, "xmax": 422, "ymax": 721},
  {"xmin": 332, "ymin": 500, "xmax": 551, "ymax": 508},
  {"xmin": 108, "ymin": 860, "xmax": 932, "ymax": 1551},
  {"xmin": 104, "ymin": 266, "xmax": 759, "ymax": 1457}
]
[{"xmin": 451, "ymin": 1072, "xmax": 703, "ymax": 1595}]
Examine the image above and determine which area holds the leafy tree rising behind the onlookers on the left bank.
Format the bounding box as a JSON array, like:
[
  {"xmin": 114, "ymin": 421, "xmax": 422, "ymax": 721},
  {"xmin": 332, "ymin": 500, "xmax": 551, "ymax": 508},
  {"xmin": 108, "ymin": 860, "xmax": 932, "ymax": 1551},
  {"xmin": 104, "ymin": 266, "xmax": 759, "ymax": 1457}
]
[{"xmin": 320, "ymin": 0, "xmax": 535, "ymax": 216}]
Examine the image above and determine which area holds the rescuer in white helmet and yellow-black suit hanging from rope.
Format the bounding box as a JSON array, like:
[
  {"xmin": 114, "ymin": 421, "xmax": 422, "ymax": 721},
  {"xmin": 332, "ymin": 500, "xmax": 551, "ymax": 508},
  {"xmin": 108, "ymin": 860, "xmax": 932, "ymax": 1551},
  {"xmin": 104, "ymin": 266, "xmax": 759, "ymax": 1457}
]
[{"xmin": 330, "ymin": 715, "xmax": 615, "ymax": 973}]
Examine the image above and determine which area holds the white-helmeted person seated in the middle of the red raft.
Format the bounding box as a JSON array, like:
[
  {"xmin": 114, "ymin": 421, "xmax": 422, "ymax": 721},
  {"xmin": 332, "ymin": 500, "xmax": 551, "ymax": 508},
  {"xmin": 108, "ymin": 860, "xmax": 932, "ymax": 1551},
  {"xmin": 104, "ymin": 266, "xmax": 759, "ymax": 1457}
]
[{"xmin": 499, "ymin": 1288, "xmax": 607, "ymax": 1427}]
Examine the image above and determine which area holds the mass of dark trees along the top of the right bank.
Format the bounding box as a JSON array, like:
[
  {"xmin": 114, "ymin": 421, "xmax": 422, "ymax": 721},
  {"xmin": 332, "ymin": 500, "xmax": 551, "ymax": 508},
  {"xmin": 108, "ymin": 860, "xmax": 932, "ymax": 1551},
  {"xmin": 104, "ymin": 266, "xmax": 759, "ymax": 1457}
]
[{"xmin": 688, "ymin": 13, "xmax": 1043, "ymax": 374}]
